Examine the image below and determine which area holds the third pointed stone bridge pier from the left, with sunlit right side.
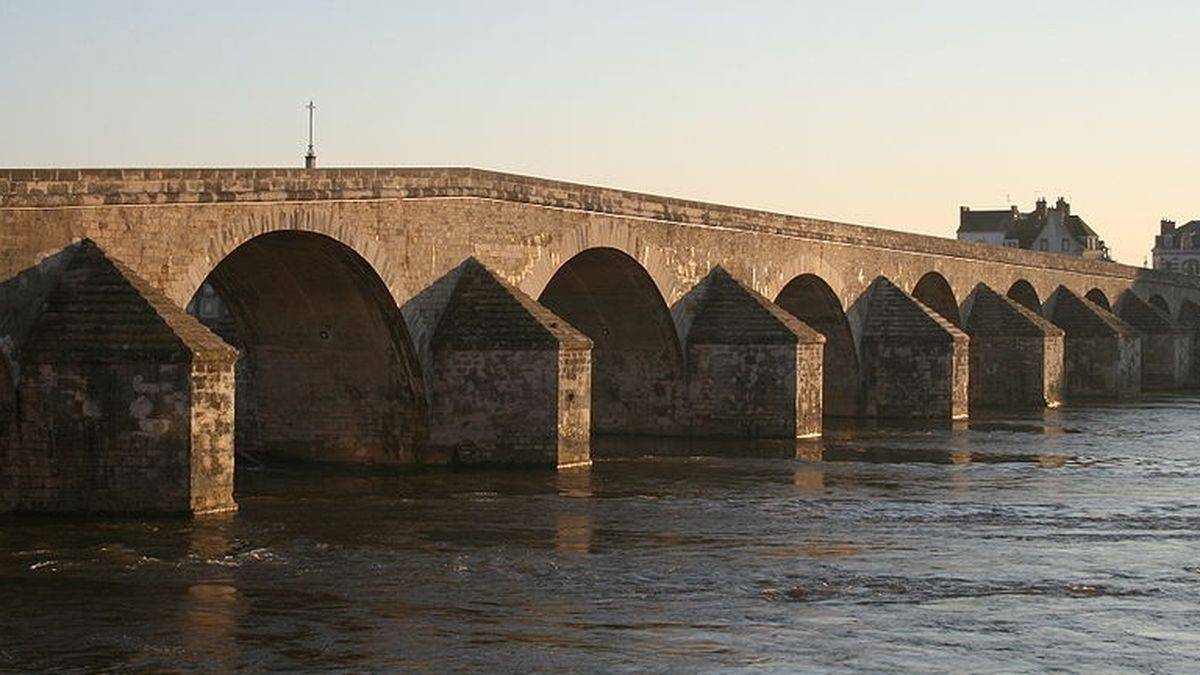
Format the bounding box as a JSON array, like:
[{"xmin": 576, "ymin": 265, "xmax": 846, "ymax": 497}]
[{"xmin": 672, "ymin": 267, "xmax": 824, "ymax": 438}]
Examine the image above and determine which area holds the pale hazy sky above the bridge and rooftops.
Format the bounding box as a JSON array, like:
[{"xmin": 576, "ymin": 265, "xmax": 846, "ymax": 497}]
[{"xmin": 0, "ymin": 0, "xmax": 1200, "ymax": 264}]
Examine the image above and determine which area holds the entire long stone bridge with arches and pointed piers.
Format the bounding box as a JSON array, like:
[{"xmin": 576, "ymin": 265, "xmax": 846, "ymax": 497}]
[{"xmin": 0, "ymin": 168, "xmax": 1200, "ymax": 513}]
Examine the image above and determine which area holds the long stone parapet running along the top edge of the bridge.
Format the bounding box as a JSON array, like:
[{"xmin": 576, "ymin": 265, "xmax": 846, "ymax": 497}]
[{"xmin": 0, "ymin": 167, "xmax": 1200, "ymax": 291}]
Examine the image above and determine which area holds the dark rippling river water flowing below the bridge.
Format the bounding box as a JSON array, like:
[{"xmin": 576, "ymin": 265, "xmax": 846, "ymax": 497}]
[{"xmin": 0, "ymin": 396, "xmax": 1200, "ymax": 673}]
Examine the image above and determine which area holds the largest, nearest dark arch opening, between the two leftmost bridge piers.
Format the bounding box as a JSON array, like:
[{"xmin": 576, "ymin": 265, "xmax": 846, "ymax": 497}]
[{"xmin": 188, "ymin": 229, "xmax": 427, "ymax": 462}]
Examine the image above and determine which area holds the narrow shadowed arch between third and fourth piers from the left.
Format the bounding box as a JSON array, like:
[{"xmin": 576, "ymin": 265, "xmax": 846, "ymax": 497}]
[{"xmin": 775, "ymin": 274, "xmax": 859, "ymax": 417}]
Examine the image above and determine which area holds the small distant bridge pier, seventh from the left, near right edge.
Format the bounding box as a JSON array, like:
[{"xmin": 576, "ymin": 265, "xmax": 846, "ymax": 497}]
[{"xmin": 1112, "ymin": 291, "xmax": 1193, "ymax": 389}]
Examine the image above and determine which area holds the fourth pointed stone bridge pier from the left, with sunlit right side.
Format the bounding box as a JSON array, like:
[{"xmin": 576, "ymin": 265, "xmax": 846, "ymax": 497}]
[{"xmin": 859, "ymin": 276, "xmax": 970, "ymax": 419}]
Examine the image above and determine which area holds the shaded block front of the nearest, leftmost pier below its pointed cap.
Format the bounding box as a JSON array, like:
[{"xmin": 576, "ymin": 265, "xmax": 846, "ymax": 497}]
[{"xmin": 4, "ymin": 363, "xmax": 191, "ymax": 513}]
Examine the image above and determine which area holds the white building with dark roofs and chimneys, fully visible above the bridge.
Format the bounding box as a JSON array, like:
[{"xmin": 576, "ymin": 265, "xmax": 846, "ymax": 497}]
[{"xmin": 958, "ymin": 197, "xmax": 1111, "ymax": 261}]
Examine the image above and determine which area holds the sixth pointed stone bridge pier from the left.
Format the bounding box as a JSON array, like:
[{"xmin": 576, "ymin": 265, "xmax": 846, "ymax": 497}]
[{"xmin": 1042, "ymin": 286, "xmax": 1141, "ymax": 399}]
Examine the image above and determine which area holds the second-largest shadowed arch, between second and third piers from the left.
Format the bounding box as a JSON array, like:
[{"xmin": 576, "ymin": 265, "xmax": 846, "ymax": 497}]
[{"xmin": 538, "ymin": 247, "xmax": 683, "ymax": 434}]
